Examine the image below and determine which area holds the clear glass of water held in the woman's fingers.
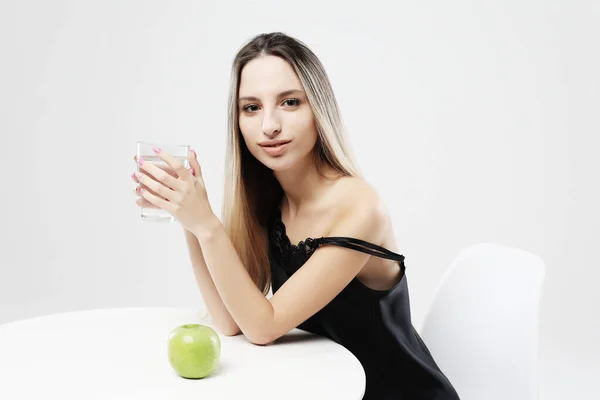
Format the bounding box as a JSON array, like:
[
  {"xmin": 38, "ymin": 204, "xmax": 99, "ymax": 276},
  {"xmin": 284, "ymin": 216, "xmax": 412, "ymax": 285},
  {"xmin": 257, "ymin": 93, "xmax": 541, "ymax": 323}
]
[{"xmin": 137, "ymin": 142, "xmax": 190, "ymax": 222}]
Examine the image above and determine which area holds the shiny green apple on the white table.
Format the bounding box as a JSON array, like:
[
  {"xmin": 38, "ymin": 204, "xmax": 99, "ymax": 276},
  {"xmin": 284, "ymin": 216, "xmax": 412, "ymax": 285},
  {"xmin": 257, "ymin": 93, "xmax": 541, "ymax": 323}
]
[{"xmin": 169, "ymin": 324, "xmax": 221, "ymax": 379}]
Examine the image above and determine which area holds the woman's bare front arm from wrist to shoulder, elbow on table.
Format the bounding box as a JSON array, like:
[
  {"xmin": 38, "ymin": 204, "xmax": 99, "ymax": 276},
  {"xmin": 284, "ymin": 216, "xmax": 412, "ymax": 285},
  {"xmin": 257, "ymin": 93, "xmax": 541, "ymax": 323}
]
[{"xmin": 196, "ymin": 202, "xmax": 386, "ymax": 344}]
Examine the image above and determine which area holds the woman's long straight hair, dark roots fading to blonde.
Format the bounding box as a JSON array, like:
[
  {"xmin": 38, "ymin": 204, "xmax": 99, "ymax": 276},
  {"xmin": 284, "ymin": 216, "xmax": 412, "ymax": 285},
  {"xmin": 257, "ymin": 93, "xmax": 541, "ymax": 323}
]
[{"xmin": 221, "ymin": 32, "xmax": 361, "ymax": 295}]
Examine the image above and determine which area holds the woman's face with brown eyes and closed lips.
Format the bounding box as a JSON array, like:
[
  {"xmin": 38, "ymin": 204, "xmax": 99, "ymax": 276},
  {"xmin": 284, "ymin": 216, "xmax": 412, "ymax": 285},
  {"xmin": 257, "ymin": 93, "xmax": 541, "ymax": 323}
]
[{"xmin": 238, "ymin": 56, "xmax": 317, "ymax": 171}]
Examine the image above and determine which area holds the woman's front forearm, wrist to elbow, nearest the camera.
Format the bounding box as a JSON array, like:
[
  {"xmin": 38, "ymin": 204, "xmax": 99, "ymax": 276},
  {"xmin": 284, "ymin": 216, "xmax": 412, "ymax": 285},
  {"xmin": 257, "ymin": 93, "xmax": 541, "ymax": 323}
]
[{"xmin": 195, "ymin": 217, "xmax": 273, "ymax": 343}]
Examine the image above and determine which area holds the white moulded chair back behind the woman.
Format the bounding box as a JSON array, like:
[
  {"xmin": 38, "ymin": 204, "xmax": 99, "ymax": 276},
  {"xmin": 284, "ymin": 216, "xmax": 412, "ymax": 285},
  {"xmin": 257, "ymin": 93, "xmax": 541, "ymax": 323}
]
[{"xmin": 419, "ymin": 243, "xmax": 545, "ymax": 400}]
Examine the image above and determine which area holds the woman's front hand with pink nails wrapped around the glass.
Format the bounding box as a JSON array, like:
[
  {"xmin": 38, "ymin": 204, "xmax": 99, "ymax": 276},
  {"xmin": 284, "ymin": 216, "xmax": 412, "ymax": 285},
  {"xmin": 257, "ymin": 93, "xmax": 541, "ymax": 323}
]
[{"xmin": 137, "ymin": 149, "xmax": 216, "ymax": 233}]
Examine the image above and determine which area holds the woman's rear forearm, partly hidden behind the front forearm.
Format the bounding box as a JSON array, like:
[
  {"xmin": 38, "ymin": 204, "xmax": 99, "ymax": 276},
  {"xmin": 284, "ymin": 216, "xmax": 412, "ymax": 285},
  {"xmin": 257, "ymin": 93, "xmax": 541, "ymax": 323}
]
[{"xmin": 184, "ymin": 229, "xmax": 240, "ymax": 336}]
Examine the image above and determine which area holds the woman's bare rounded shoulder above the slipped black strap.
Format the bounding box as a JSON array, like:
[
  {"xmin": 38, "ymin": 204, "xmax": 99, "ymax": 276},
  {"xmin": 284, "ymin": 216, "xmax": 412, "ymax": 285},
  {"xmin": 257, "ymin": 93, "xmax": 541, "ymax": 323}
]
[{"xmin": 332, "ymin": 177, "xmax": 391, "ymax": 238}]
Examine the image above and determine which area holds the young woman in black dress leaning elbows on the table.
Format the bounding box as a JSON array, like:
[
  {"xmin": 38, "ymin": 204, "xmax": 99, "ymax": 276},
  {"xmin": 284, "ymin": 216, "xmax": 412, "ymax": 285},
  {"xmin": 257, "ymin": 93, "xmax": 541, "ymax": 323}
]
[{"xmin": 134, "ymin": 33, "xmax": 458, "ymax": 400}]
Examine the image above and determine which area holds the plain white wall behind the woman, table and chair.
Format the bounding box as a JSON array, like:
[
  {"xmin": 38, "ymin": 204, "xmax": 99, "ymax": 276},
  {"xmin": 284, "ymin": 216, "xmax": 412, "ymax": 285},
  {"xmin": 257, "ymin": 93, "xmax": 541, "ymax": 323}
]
[{"xmin": 0, "ymin": 0, "xmax": 600, "ymax": 399}]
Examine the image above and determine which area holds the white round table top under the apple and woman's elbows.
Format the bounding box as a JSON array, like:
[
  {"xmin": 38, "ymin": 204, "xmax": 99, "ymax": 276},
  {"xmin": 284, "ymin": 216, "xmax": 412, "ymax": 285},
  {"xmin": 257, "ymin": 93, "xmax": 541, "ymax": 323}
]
[{"xmin": 0, "ymin": 307, "xmax": 365, "ymax": 400}]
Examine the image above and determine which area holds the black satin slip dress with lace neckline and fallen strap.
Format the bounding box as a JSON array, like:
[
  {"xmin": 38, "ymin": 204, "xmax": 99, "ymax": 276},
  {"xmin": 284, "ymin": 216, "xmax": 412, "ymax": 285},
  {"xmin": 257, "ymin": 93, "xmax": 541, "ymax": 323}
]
[{"xmin": 269, "ymin": 207, "xmax": 459, "ymax": 400}]
